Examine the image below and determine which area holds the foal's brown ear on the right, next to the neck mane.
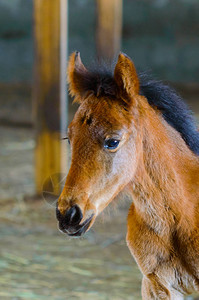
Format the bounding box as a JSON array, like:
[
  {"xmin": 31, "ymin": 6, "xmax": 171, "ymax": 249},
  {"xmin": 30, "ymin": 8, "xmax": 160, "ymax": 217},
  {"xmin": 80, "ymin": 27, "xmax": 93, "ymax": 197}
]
[{"xmin": 114, "ymin": 53, "xmax": 139, "ymax": 104}]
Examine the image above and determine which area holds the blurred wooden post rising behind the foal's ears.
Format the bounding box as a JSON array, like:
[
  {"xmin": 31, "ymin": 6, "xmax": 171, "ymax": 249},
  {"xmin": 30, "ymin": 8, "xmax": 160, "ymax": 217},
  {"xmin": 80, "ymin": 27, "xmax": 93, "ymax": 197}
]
[{"xmin": 96, "ymin": 0, "xmax": 122, "ymax": 60}]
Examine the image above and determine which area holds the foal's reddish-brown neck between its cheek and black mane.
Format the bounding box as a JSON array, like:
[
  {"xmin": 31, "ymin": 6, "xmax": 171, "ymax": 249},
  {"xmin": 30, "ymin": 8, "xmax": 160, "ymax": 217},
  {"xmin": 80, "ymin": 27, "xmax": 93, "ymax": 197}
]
[{"xmin": 131, "ymin": 104, "xmax": 199, "ymax": 232}]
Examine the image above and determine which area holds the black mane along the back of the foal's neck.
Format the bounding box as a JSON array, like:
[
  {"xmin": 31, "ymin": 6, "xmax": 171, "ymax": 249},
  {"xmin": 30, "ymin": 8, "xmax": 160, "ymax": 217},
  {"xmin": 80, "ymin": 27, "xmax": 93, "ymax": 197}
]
[{"xmin": 139, "ymin": 74, "xmax": 199, "ymax": 155}]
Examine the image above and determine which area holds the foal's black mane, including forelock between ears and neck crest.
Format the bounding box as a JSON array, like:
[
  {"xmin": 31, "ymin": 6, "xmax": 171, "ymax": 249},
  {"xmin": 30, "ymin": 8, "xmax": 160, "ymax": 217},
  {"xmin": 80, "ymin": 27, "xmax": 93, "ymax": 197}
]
[{"xmin": 82, "ymin": 65, "xmax": 199, "ymax": 155}]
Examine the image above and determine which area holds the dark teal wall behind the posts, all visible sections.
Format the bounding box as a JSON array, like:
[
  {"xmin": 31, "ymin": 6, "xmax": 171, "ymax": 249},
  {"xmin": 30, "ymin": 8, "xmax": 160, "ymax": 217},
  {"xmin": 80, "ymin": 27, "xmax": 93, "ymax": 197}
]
[{"xmin": 0, "ymin": 0, "xmax": 199, "ymax": 83}]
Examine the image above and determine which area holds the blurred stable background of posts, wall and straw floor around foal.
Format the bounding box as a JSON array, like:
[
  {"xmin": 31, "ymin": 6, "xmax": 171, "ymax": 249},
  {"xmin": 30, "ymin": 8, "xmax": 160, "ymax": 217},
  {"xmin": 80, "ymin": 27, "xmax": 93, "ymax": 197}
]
[{"xmin": 0, "ymin": 0, "xmax": 199, "ymax": 300}]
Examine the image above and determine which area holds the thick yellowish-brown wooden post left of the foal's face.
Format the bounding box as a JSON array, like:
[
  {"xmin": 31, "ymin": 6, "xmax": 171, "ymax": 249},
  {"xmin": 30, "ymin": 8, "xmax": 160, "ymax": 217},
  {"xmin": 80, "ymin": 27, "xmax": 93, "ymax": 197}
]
[{"xmin": 33, "ymin": 0, "xmax": 67, "ymax": 194}]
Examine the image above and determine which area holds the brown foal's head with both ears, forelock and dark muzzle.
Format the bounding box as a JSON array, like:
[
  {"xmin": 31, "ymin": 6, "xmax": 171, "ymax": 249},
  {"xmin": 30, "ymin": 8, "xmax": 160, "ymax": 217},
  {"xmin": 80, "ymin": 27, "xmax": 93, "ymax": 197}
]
[{"xmin": 57, "ymin": 53, "xmax": 142, "ymax": 236}]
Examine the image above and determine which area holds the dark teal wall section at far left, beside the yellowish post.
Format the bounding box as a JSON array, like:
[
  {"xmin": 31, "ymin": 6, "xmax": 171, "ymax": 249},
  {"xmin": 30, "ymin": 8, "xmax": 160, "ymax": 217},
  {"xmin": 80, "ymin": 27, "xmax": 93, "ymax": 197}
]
[{"xmin": 0, "ymin": 0, "xmax": 33, "ymax": 83}]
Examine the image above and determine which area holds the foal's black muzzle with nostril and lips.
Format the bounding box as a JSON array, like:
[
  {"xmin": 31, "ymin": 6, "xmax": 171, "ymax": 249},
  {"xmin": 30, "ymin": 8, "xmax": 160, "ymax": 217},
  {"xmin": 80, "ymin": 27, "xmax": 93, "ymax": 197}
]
[{"xmin": 56, "ymin": 205, "xmax": 93, "ymax": 236}]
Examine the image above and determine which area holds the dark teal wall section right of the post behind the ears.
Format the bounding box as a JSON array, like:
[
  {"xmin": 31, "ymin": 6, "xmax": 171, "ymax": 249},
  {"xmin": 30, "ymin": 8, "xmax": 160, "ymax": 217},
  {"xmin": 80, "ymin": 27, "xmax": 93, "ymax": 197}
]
[{"xmin": 123, "ymin": 0, "xmax": 199, "ymax": 82}]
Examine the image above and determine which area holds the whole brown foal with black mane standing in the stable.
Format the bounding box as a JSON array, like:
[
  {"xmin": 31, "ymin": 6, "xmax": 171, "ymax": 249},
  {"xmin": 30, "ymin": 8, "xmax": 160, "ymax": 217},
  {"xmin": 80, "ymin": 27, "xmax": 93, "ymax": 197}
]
[{"xmin": 57, "ymin": 52, "xmax": 199, "ymax": 300}]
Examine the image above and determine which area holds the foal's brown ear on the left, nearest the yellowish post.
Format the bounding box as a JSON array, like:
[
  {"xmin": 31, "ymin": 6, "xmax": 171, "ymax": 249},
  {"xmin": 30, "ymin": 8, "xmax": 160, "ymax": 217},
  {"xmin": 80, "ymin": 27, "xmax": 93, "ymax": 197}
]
[{"xmin": 67, "ymin": 52, "xmax": 88, "ymax": 102}]
